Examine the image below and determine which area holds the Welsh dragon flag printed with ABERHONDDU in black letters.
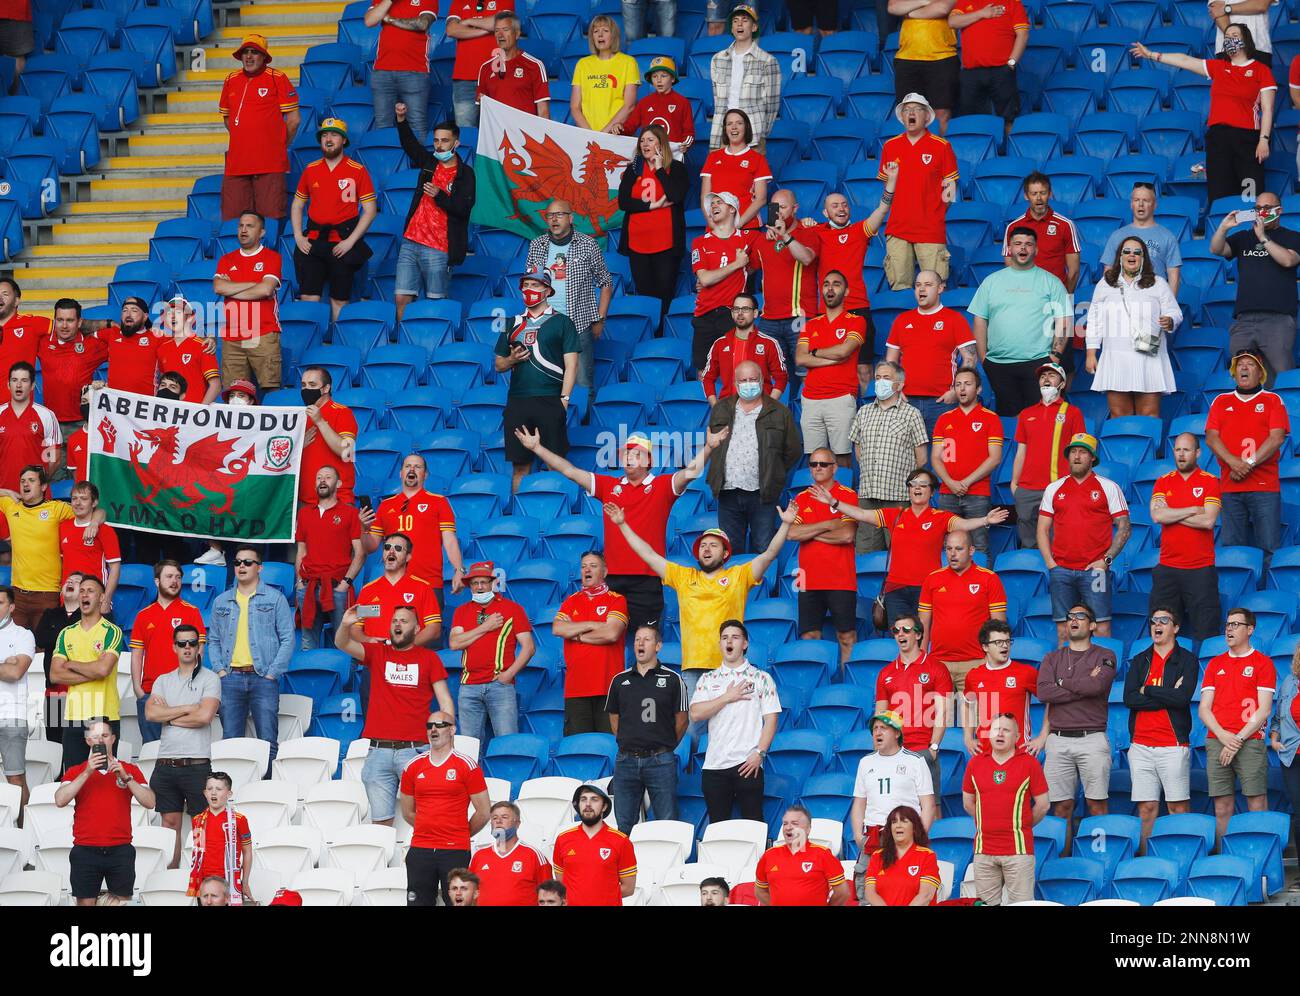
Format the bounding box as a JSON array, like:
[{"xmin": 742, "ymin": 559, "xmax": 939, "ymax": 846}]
[{"xmin": 86, "ymin": 387, "xmax": 307, "ymax": 542}]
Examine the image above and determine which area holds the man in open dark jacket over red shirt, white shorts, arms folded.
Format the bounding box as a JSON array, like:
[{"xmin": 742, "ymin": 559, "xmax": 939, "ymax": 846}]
[{"xmin": 1125, "ymin": 603, "xmax": 1196, "ymax": 848}]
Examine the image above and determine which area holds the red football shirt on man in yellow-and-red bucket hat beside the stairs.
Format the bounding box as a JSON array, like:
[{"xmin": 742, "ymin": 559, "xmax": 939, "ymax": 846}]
[{"xmin": 217, "ymin": 66, "xmax": 298, "ymax": 177}]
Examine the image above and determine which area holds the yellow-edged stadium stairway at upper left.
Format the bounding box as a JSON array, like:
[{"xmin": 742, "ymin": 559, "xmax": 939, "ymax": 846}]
[{"xmin": 13, "ymin": 0, "xmax": 346, "ymax": 315}]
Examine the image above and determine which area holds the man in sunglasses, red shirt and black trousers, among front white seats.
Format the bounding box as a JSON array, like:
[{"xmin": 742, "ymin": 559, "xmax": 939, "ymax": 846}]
[{"xmin": 398, "ymin": 711, "xmax": 489, "ymax": 906}]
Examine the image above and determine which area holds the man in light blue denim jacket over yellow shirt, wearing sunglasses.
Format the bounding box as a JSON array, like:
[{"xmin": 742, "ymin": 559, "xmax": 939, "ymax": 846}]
[{"xmin": 208, "ymin": 546, "xmax": 294, "ymax": 763}]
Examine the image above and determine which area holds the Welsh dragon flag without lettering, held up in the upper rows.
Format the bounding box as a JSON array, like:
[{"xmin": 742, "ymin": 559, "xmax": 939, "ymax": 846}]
[{"xmin": 471, "ymin": 96, "xmax": 637, "ymax": 239}]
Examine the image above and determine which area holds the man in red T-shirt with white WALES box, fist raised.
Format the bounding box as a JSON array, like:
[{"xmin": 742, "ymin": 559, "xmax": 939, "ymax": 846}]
[{"xmin": 334, "ymin": 605, "xmax": 456, "ymax": 826}]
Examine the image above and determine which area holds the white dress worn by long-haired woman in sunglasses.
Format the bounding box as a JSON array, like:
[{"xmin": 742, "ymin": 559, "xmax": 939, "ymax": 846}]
[{"xmin": 1087, "ymin": 274, "xmax": 1183, "ymax": 394}]
